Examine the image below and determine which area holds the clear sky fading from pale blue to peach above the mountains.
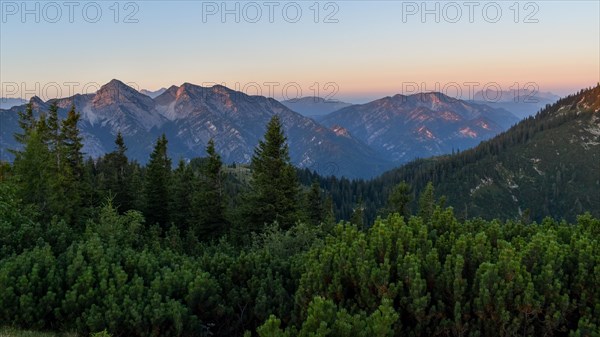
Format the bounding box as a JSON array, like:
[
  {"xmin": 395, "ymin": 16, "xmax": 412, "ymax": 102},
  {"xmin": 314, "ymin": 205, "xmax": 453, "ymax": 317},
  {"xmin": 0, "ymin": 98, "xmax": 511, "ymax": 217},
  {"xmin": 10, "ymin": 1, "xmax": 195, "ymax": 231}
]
[{"xmin": 0, "ymin": 0, "xmax": 600, "ymax": 103}]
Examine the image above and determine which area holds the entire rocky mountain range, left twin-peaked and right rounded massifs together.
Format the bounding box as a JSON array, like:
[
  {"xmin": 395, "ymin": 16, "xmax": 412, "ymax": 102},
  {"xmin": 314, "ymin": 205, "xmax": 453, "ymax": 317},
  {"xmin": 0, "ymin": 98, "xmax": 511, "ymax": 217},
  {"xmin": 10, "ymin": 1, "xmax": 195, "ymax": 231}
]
[{"xmin": 0, "ymin": 80, "xmax": 517, "ymax": 178}]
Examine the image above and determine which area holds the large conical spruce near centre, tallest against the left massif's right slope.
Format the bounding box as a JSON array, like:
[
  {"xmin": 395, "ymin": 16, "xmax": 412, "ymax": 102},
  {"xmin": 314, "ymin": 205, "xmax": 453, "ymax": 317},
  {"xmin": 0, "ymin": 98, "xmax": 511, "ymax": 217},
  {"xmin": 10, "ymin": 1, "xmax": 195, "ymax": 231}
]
[{"xmin": 242, "ymin": 116, "xmax": 300, "ymax": 232}]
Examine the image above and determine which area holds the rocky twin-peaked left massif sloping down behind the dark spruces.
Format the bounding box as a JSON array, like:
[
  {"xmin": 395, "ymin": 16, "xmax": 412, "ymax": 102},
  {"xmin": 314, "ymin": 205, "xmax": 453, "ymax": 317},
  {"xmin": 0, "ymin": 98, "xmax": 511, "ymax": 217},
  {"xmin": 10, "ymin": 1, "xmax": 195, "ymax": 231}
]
[{"xmin": 0, "ymin": 80, "xmax": 392, "ymax": 177}]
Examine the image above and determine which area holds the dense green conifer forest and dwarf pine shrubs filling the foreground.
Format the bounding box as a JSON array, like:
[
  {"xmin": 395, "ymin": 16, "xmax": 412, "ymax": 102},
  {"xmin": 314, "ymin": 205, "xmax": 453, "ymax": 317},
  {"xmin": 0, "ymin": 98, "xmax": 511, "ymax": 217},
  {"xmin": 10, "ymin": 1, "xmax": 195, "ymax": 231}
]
[{"xmin": 0, "ymin": 92, "xmax": 600, "ymax": 337}]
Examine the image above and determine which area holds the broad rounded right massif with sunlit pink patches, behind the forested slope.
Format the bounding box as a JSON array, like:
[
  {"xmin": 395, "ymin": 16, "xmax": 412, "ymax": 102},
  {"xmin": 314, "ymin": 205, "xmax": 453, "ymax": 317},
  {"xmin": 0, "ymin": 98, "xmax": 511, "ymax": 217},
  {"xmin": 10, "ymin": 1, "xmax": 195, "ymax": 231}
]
[{"xmin": 321, "ymin": 93, "xmax": 519, "ymax": 163}]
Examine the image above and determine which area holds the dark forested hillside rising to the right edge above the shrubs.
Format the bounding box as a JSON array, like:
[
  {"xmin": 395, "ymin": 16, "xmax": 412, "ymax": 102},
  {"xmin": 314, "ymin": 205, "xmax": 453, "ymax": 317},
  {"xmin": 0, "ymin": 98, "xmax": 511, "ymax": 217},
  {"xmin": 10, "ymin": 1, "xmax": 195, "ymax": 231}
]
[{"xmin": 308, "ymin": 86, "xmax": 600, "ymax": 221}]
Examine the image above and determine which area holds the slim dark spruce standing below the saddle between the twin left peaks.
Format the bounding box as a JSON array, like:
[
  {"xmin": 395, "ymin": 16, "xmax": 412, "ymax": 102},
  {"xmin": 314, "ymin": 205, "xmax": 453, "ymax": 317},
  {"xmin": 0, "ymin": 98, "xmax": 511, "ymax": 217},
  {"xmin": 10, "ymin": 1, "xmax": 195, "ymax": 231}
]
[{"xmin": 144, "ymin": 134, "xmax": 171, "ymax": 227}]
